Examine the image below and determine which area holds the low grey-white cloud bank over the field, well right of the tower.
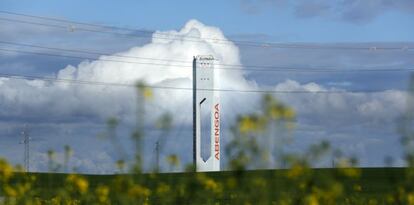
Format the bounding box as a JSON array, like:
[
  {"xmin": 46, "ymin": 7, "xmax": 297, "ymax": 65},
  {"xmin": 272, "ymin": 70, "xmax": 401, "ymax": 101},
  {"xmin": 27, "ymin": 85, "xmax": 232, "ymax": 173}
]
[{"xmin": 275, "ymin": 80, "xmax": 406, "ymax": 124}]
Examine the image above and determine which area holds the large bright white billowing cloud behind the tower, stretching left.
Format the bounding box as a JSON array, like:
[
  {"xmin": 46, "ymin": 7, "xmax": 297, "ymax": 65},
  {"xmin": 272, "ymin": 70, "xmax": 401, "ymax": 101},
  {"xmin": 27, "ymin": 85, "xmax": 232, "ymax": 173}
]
[{"xmin": 0, "ymin": 20, "xmax": 252, "ymax": 124}]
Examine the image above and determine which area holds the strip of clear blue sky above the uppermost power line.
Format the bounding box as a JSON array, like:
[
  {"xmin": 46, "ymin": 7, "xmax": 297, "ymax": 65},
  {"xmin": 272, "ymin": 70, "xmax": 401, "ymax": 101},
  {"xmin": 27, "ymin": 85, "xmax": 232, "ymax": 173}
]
[{"xmin": 0, "ymin": 0, "xmax": 414, "ymax": 42}]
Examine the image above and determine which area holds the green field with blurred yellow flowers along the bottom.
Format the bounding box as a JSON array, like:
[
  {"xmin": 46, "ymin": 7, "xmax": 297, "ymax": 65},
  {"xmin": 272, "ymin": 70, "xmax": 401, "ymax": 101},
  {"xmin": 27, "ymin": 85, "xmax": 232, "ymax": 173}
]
[{"xmin": 0, "ymin": 167, "xmax": 413, "ymax": 205}]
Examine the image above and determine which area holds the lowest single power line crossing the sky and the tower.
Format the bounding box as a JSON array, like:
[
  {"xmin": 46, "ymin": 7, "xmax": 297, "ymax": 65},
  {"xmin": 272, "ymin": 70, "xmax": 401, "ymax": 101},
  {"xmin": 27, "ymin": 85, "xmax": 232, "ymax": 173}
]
[{"xmin": 0, "ymin": 73, "xmax": 398, "ymax": 94}]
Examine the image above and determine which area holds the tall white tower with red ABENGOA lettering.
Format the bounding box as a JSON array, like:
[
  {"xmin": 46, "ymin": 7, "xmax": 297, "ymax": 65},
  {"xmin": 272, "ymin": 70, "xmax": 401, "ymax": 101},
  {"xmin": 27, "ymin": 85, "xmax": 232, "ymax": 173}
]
[{"xmin": 193, "ymin": 56, "xmax": 220, "ymax": 172}]
